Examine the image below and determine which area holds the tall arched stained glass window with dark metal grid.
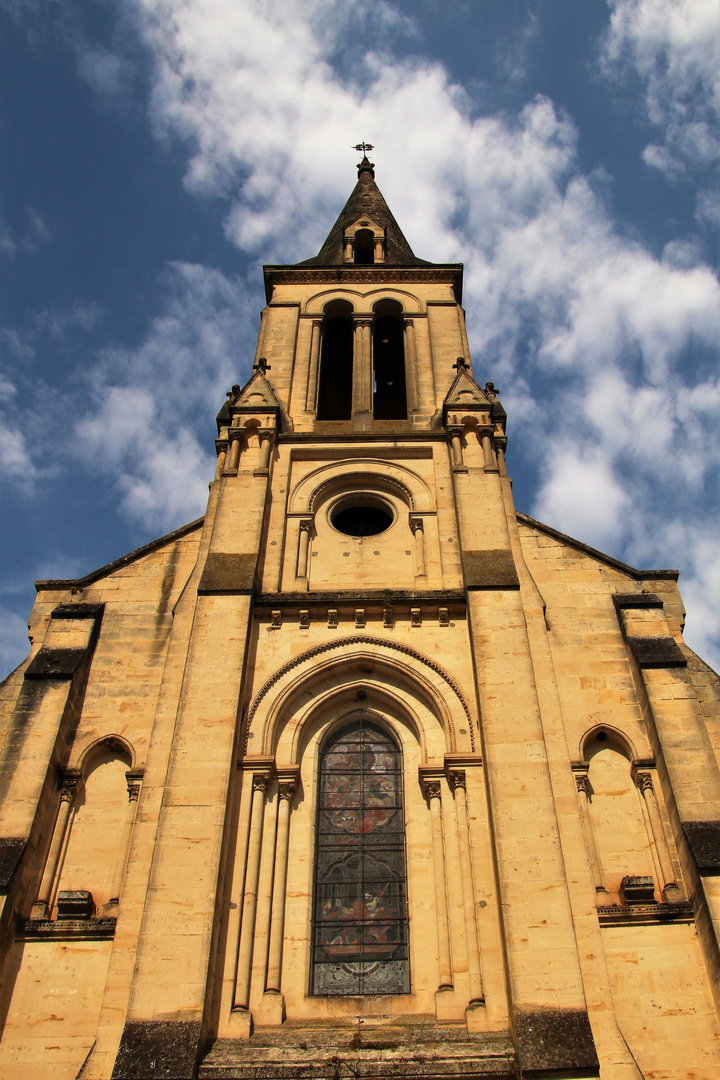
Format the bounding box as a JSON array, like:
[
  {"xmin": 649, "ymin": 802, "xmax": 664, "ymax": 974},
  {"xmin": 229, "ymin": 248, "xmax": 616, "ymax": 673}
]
[{"xmin": 312, "ymin": 719, "xmax": 410, "ymax": 995}]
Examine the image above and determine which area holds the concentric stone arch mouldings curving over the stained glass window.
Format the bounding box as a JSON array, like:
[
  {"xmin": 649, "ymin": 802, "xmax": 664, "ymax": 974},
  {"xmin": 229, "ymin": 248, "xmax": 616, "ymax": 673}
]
[{"xmin": 246, "ymin": 635, "xmax": 474, "ymax": 768}]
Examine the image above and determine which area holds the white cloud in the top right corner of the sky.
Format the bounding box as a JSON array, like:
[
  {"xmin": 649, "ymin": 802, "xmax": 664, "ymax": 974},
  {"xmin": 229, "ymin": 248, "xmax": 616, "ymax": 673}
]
[{"xmin": 602, "ymin": 0, "xmax": 720, "ymax": 210}]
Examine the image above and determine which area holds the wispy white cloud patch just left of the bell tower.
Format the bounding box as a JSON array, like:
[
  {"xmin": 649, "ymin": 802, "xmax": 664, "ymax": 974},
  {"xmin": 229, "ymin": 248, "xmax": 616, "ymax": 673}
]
[{"xmin": 74, "ymin": 264, "xmax": 259, "ymax": 529}]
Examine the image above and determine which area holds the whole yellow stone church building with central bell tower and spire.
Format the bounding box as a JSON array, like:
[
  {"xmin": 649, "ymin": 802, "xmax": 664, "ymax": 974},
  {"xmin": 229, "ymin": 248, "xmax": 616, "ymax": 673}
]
[{"xmin": 0, "ymin": 159, "xmax": 720, "ymax": 1080}]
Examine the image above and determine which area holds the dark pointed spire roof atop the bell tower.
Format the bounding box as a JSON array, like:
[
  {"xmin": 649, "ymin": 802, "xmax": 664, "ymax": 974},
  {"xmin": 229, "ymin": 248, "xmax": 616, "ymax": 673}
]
[{"xmin": 297, "ymin": 158, "xmax": 432, "ymax": 267}]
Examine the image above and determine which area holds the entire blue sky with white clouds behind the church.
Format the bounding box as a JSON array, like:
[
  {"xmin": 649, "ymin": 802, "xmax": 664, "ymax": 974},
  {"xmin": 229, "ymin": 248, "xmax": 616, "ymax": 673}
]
[{"xmin": 0, "ymin": 0, "xmax": 720, "ymax": 671}]
